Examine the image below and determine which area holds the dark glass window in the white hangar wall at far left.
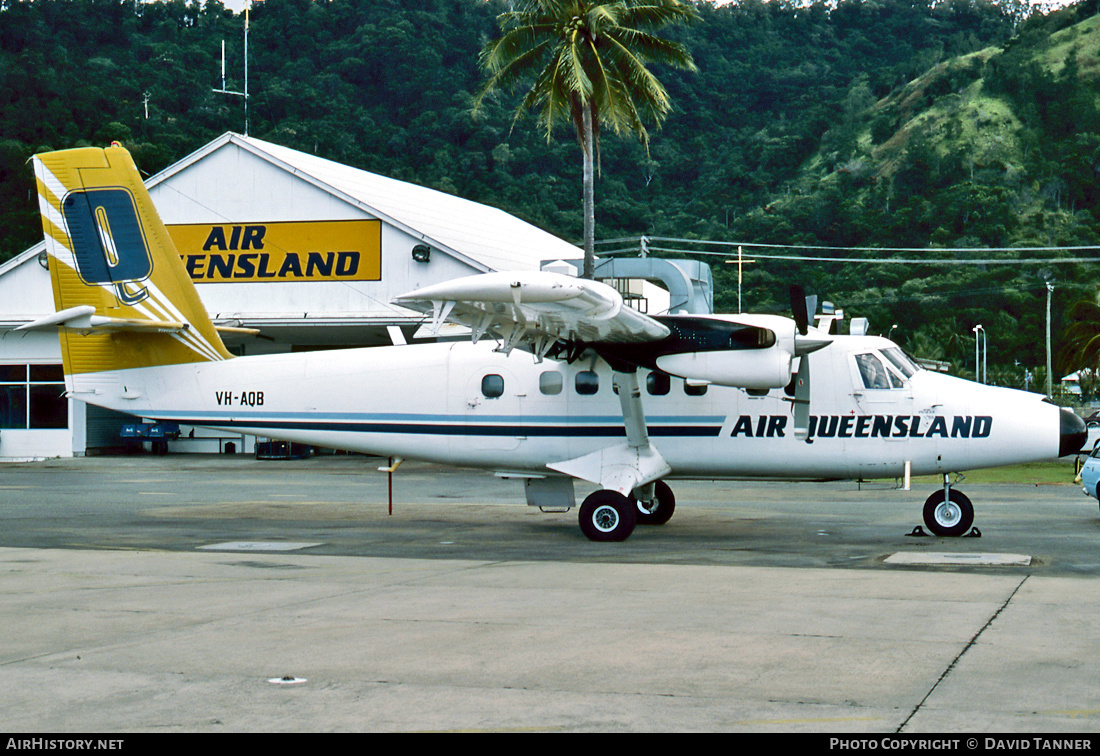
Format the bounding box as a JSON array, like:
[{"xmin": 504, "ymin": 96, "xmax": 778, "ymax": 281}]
[{"xmin": 0, "ymin": 364, "xmax": 68, "ymax": 429}]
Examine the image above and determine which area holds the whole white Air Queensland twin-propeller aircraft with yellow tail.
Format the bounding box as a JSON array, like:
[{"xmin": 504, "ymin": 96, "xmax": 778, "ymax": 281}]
[{"xmin": 24, "ymin": 146, "xmax": 1086, "ymax": 540}]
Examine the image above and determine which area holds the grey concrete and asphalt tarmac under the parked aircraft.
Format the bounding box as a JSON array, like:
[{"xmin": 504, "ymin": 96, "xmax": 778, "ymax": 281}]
[{"xmin": 0, "ymin": 458, "xmax": 1100, "ymax": 735}]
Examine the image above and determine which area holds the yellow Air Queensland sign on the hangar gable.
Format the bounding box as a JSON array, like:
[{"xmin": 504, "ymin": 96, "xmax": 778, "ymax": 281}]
[{"xmin": 167, "ymin": 220, "xmax": 382, "ymax": 284}]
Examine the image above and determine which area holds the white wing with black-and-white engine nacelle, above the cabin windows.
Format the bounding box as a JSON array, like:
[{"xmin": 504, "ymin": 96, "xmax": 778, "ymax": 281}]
[{"xmin": 395, "ymin": 271, "xmax": 832, "ymax": 391}]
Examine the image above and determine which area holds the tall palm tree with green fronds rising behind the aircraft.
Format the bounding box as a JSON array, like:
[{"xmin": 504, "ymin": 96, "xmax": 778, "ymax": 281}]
[{"xmin": 475, "ymin": 0, "xmax": 697, "ymax": 278}]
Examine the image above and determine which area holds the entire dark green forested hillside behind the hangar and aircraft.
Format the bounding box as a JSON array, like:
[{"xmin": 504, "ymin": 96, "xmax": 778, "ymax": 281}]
[{"xmin": 0, "ymin": 0, "xmax": 1100, "ymax": 382}]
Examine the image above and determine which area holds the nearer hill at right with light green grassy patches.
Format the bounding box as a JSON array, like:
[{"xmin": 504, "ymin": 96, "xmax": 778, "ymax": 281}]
[{"xmin": 737, "ymin": 2, "xmax": 1100, "ymax": 386}]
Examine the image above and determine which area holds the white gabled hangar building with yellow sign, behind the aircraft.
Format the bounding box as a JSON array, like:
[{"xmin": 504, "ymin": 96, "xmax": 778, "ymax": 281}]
[{"xmin": 0, "ymin": 133, "xmax": 580, "ymax": 459}]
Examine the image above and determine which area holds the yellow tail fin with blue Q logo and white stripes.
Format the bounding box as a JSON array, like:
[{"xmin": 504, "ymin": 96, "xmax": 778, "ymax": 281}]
[{"xmin": 31, "ymin": 146, "xmax": 231, "ymax": 374}]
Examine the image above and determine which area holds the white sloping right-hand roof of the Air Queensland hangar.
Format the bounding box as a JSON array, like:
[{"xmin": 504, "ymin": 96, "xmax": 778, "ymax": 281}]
[{"xmin": 223, "ymin": 134, "xmax": 581, "ymax": 271}]
